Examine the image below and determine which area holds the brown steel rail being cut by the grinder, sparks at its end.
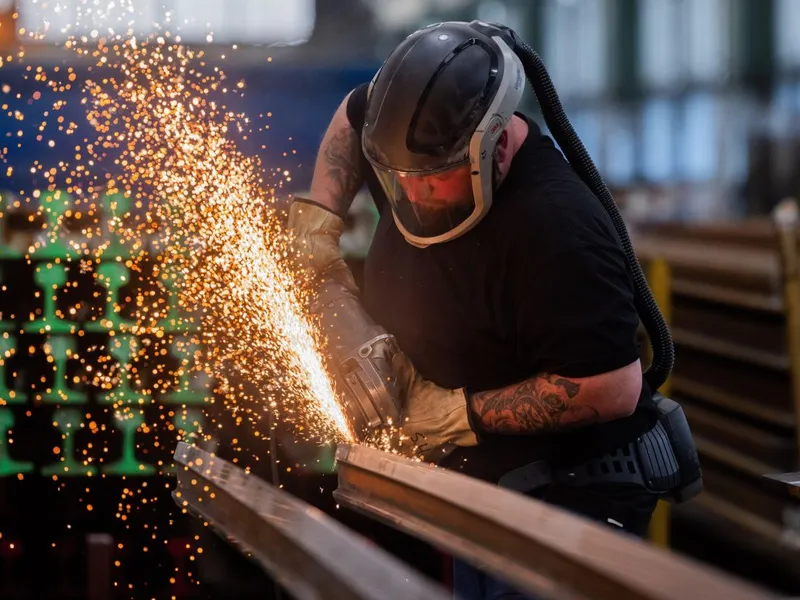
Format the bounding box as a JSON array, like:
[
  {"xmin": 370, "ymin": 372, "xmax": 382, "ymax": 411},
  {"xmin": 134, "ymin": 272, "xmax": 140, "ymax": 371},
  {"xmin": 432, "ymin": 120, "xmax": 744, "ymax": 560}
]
[{"xmin": 334, "ymin": 445, "xmax": 779, "ymax": 600}]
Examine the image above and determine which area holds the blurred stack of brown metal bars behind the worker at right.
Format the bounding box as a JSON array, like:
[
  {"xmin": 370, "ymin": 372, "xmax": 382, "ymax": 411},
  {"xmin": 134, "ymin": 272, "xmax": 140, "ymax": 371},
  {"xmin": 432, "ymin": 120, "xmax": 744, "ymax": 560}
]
[{"xmin": 634, "ymin": 212, "xmax": 800, "ymax": 589}]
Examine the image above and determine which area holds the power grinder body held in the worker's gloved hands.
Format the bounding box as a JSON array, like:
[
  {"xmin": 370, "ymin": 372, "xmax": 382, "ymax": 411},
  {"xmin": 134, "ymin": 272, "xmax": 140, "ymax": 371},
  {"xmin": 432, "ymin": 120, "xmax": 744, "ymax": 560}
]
[{"xmin": 311, "ymin": 279, "xmax": 401, "ymax": 440}]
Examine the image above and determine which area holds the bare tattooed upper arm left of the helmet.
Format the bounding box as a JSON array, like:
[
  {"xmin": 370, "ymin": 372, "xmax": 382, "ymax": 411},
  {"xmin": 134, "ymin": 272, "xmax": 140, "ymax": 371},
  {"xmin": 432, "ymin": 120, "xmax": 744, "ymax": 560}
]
[{"xmin": 310, "ymin": 92, "xmax": 364, "ymax": 215}]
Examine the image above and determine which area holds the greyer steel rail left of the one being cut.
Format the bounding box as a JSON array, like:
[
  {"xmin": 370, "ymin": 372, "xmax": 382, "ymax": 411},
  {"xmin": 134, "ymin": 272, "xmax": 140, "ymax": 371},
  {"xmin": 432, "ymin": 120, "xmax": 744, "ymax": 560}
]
[{"xmin": 172, "ymin": 442, "xmax": 450, "ymax": 600}]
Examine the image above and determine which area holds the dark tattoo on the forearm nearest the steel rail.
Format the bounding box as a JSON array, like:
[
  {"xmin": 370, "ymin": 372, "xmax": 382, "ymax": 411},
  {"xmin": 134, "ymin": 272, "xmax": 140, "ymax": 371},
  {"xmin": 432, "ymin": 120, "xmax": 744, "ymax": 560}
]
[{"xmin": 470, "ymin": 374, "xmax": 600, "ymax": 434}]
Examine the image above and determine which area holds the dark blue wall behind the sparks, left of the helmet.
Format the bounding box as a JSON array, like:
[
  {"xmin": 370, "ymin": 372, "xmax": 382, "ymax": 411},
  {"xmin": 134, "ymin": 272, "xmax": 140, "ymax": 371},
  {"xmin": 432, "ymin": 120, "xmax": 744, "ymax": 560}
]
[{"xmin": 0, "ymin": 64, "xmax": 379, "ymax": 191}]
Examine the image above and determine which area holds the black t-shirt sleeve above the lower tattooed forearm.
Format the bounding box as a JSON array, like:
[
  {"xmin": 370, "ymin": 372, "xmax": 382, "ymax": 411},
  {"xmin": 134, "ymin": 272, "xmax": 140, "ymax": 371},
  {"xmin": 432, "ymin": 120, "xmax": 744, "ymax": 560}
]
[{"xmin": 509, "ymin": 204, "xmax": 639, "ymax": 377}]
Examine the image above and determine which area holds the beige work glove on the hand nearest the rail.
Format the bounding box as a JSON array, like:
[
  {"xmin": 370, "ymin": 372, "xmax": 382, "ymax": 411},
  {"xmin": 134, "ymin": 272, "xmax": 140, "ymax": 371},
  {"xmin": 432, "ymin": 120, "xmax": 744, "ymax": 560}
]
[{"xmin": 392, "ymin": 352, "xmax": 478, "ymax": 462}]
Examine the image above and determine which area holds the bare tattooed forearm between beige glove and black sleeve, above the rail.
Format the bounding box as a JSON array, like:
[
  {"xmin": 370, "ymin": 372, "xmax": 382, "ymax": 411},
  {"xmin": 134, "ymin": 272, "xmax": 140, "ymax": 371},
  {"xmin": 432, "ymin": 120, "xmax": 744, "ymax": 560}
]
[{"xmin": 469, "ymin": 360, "xmax": 642, "ymax": 434}]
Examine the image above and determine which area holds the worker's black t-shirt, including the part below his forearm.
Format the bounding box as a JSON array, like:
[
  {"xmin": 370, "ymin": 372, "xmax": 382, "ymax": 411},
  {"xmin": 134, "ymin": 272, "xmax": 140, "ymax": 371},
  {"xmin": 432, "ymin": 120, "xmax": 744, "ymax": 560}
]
[{"xmin": 348, "ymin": 85, "xmax": 652, "ymax": 481}]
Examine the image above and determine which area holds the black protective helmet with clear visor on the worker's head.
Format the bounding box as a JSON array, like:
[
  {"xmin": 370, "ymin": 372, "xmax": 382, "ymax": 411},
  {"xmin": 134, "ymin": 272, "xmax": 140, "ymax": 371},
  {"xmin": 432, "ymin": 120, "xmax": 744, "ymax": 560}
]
[{"xmin": 362, "ymin": 22, "xmax": 525, "ymax": 247}]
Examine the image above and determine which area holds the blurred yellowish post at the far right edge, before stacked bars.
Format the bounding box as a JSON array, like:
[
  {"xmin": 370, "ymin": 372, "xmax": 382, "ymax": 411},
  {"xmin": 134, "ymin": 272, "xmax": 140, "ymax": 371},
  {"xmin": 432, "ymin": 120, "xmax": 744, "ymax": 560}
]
[{"xmin": 772, "ymin": 198, "xmax": 800, "ymax": 468}]
